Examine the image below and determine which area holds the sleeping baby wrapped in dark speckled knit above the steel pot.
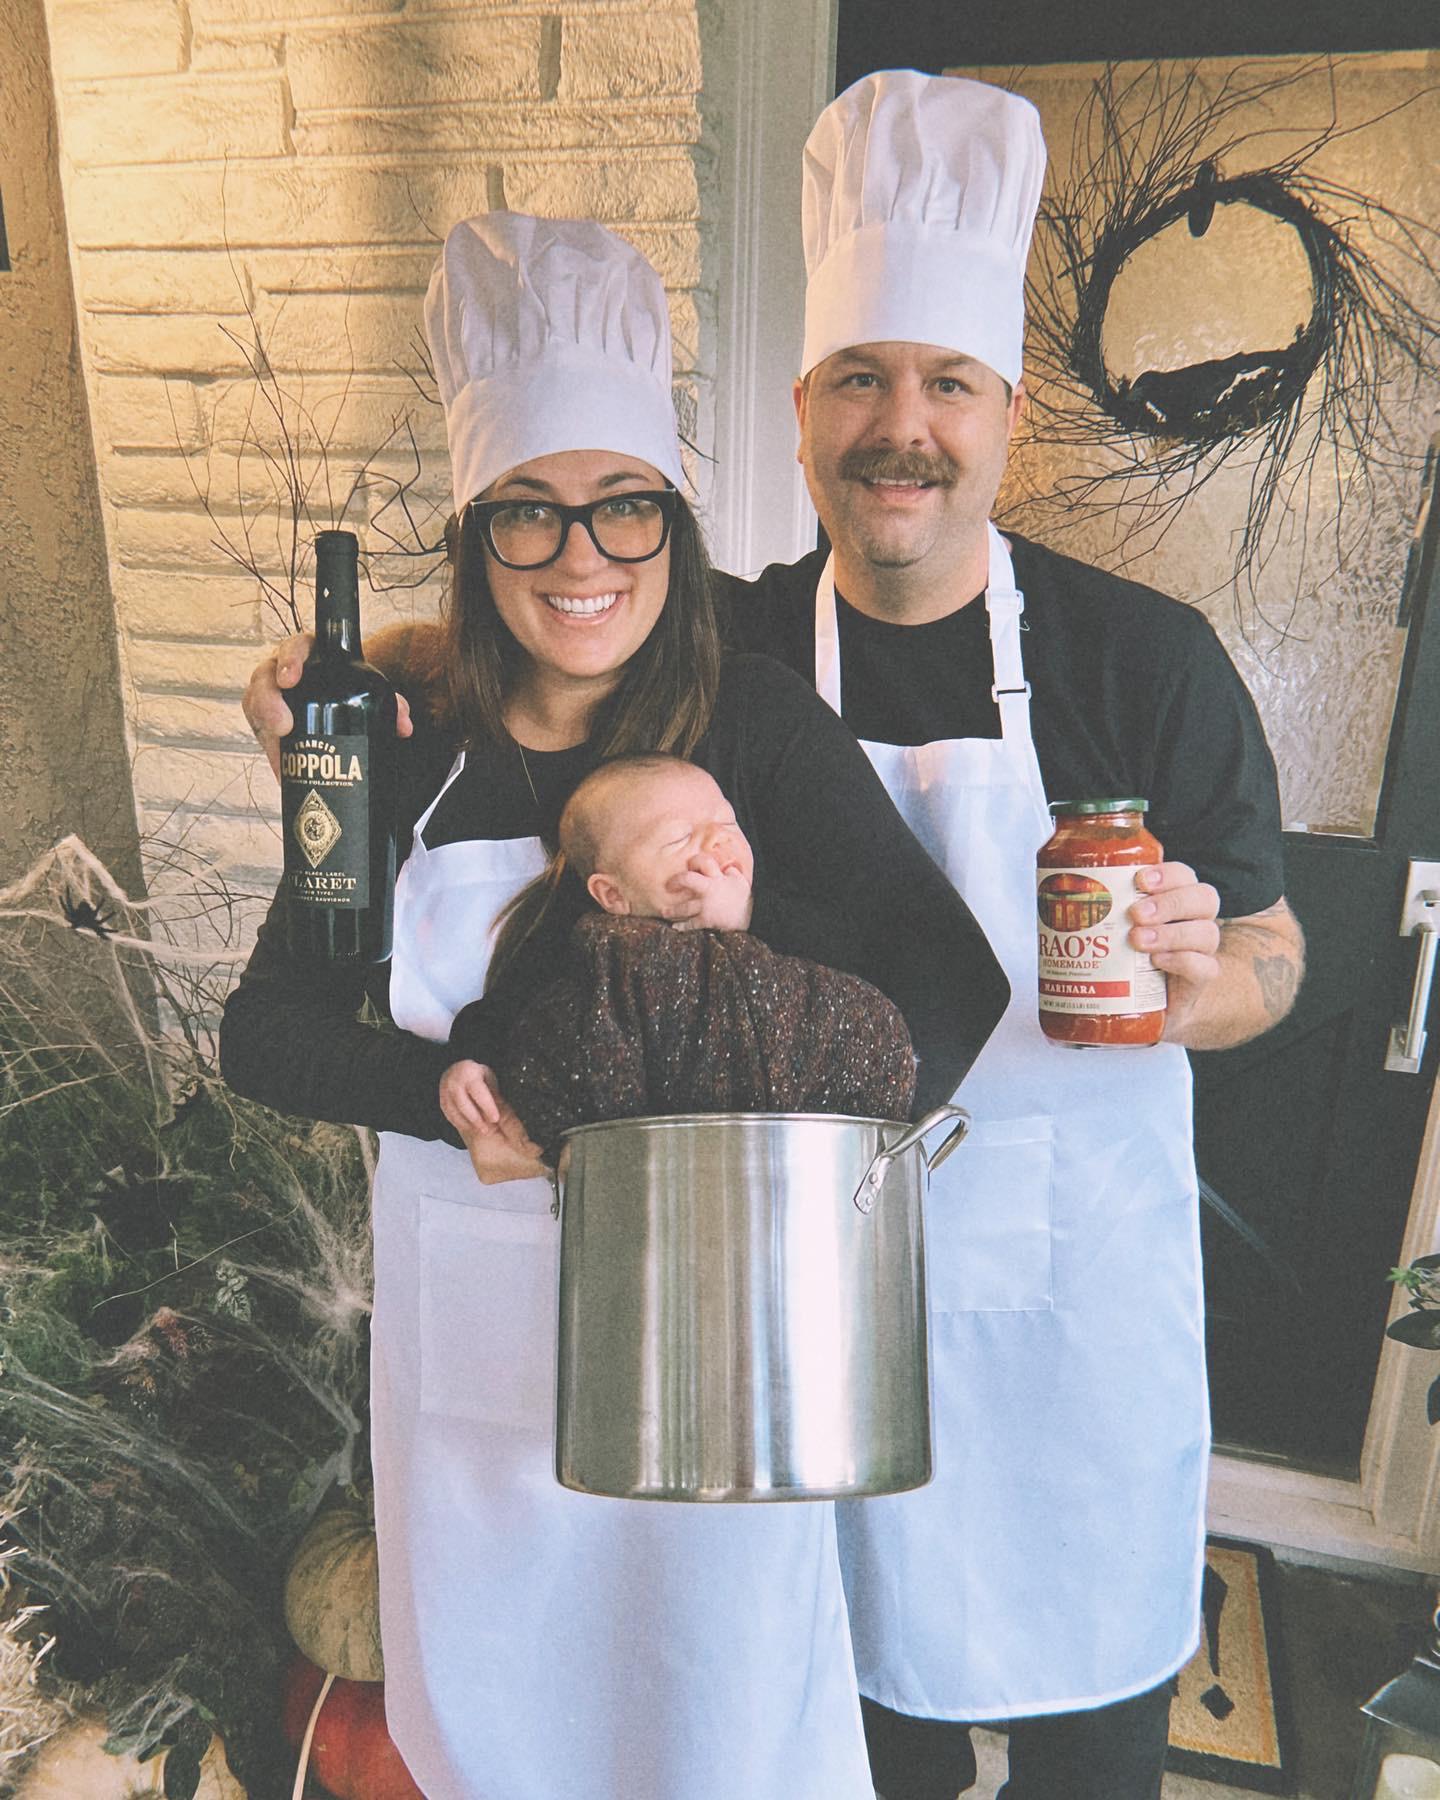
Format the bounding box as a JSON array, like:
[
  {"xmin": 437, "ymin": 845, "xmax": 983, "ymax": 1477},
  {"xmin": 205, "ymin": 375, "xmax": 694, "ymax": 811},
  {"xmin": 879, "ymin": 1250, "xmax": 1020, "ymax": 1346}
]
[{"xmin": 441, "ymin": 756, "xmax": 914, "ymax": 1163}]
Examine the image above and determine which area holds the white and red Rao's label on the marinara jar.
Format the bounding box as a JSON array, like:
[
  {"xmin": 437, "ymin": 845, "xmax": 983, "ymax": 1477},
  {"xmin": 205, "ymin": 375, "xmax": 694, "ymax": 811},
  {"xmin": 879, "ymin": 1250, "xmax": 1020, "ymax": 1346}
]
[{"xmin": 1035, "ymin": 868, "xmax": 1165, "ymax": 1017}]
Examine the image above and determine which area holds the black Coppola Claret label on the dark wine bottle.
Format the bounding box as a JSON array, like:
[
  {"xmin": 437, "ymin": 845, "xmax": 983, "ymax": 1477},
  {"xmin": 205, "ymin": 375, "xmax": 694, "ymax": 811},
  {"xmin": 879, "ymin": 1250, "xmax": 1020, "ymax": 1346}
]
[{"xmin": 281, "ymin": 736, "xmax": 371, "ymax": 909}]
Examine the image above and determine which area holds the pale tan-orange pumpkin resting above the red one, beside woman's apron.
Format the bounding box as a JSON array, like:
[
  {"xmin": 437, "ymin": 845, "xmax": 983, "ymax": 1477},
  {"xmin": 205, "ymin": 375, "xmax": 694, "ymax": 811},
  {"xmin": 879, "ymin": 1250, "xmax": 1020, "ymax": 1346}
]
[{"xmin": 284, "ymin": 1505, "xmax": 385, "ymax": 1681}]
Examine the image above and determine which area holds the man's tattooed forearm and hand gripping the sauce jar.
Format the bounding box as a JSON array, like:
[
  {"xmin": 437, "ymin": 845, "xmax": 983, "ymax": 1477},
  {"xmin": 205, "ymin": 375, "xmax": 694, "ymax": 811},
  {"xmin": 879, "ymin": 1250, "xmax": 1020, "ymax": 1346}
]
[{"xmin": 1130, "ymin": 862, "xmax": 1305, "ymax": 1049}]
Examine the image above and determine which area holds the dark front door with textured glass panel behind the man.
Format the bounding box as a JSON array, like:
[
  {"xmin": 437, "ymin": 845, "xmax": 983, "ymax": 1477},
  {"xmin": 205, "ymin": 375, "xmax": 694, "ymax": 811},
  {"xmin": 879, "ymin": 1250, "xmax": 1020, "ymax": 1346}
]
[{"xmin": 837, "ymin": 0, "xmax": 1440, "ymax": 1566}]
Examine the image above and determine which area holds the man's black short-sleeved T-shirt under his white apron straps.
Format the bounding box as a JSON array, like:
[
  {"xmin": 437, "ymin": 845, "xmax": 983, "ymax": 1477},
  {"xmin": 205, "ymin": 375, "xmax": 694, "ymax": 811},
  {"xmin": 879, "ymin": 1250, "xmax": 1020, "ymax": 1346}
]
[{"xmin": 720, "ymin": 531, "xmax": 1285, "ymax": 918}]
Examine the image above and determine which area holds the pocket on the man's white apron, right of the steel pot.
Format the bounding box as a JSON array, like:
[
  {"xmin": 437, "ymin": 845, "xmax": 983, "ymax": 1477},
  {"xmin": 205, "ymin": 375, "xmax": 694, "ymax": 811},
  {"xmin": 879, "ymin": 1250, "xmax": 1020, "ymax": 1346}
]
[{"xmin": 925, "ymin": 1112, "xmax": 1055, "ymax": 1312}]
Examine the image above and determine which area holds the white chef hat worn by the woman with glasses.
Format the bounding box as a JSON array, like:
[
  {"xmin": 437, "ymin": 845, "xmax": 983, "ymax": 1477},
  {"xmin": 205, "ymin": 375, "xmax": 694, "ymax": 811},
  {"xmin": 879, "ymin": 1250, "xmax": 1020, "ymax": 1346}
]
[{"xmin": 425, "ymin": 212, "xmax": 684, "ymax": 511}]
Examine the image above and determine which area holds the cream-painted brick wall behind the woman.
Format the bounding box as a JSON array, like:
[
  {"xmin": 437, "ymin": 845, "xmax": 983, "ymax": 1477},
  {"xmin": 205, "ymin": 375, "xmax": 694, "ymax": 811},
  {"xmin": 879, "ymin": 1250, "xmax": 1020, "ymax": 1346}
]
[{"xmin": 47, "ymin": 0, "xmax": 707, "ymax": 921}]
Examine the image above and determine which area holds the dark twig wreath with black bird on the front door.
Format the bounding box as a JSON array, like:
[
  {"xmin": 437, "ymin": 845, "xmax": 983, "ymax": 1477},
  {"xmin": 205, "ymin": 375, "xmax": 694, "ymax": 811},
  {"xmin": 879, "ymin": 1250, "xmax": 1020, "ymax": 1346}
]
[{"xmin": 1024, "ymin": 59, "xmax": 1440, "ymax": 630}]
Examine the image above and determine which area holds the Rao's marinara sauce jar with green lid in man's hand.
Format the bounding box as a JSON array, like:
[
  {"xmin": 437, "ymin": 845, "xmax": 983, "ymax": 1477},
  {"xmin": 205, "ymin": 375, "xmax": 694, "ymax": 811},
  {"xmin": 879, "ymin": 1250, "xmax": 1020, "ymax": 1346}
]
[{"xmin": 1035, "ymin": 799, "xmax": 1165, "ymax": 1046}]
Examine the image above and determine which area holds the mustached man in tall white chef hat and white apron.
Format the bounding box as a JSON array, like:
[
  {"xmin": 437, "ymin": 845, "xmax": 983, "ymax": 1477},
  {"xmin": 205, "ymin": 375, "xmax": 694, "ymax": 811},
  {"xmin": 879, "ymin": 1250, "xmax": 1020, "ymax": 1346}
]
[{"xmin": 720, "ymin": 70, "xmax": 1301, "ymax": 1800}]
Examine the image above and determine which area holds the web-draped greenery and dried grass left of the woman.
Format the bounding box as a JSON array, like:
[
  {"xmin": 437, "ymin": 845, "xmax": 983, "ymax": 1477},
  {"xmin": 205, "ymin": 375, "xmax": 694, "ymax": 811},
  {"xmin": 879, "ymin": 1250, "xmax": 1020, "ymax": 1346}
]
[{"xmin": 0, "ymin": 839, "xmax": 371, "ymax": 1800}]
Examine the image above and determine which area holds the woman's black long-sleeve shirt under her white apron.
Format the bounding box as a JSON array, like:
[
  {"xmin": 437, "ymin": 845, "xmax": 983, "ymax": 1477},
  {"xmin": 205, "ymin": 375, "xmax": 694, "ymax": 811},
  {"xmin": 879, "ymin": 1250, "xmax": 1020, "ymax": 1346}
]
[{"xmin": 220, "ymin": 655, "xmax": 1008, "ymax": 1141}]
